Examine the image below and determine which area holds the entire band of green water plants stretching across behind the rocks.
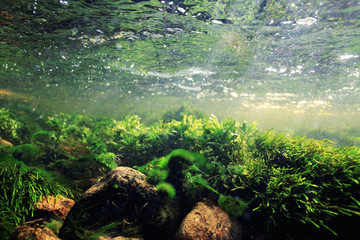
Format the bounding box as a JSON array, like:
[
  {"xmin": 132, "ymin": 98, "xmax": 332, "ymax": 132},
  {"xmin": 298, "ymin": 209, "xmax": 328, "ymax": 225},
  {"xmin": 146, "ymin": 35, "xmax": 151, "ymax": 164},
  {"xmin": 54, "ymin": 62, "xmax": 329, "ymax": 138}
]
[{"xmin": 2, "ymin": 106, "xmax": 360, "ymax": 237}]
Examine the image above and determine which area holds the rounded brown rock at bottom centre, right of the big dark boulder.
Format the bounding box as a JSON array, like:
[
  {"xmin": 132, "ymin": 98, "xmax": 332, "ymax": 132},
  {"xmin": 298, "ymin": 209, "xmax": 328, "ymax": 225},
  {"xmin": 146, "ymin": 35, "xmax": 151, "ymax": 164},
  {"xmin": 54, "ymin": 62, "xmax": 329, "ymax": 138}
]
[{"xmin": 176, "ymin": 201, "xmax": 242, "ymax": 240}]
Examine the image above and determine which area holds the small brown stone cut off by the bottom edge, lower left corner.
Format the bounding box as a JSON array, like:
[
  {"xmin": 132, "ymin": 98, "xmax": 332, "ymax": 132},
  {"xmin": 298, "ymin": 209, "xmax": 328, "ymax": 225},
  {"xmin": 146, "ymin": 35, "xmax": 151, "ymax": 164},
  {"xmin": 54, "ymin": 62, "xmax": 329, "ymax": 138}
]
[{"xmin": 15, "ymin": 225, "xmax": 60, "ymax": 240}]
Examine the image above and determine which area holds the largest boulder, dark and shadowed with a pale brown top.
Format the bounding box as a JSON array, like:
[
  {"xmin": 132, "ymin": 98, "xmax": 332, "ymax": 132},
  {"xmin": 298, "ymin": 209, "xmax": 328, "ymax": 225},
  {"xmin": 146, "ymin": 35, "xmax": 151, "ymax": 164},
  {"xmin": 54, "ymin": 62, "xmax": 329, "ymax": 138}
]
[{"xmin": 59, "ymin": 167, "xmax": 174, "ymax": 240}]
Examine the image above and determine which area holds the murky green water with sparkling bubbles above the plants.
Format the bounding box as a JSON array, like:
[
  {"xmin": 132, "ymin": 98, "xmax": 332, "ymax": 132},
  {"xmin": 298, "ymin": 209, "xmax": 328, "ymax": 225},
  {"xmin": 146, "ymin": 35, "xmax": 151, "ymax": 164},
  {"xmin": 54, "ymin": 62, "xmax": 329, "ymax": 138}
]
[{"xmin": 0, "ymin": 0, "xmax": 360, "ymax": 142}]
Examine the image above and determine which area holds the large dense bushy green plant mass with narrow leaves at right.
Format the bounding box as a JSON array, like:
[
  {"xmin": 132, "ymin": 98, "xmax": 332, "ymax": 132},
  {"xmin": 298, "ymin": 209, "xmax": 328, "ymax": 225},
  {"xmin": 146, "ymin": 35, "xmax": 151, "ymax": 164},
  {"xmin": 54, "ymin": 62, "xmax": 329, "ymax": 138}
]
[{"xmin": 236, "ymin": 131, "xmax": 360, "ymax": 234}]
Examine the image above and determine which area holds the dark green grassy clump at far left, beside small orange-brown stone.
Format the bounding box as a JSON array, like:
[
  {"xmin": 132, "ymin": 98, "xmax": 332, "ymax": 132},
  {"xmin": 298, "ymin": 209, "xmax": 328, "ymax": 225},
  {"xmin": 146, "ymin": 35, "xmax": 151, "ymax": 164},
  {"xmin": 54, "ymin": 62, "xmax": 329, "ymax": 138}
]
[{"xmin": 0, "ymin": 162, "xmax": 72, "ymax": 238}]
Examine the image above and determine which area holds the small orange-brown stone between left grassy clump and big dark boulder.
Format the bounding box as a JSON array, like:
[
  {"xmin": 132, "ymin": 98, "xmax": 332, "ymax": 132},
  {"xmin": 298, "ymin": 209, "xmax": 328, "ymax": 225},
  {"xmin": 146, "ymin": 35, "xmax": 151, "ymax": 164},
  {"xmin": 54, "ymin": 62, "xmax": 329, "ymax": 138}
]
[{"xmin": 34, "ymin": 195, "xmax": 75, "ymax": 221}]
